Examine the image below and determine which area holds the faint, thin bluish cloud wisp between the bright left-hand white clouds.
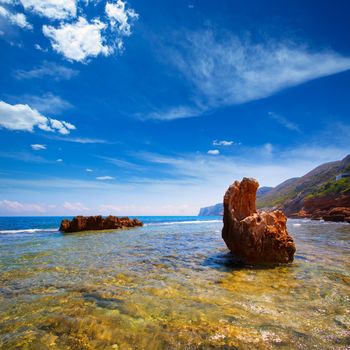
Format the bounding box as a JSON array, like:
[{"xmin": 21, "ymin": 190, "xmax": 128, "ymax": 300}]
[{"xmin": 14, "ymin": 61, "xmax": 78, "ymax": 81}]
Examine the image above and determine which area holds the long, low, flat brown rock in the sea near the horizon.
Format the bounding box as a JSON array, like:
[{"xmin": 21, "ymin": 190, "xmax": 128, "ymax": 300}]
[{"xmin": 60, "ymin": 215, "xmax": 143, "ymax": 232}]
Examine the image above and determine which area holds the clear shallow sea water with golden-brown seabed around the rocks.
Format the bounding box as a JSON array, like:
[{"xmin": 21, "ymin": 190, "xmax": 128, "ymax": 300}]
[{"xmin": 0, "ymin": 217, "xmax": 350, "ymax": 350}]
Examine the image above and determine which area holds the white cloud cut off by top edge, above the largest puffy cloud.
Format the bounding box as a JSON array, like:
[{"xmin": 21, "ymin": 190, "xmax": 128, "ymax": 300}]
[{"xmin": 20, "ymin": 0, "xmax": 77, "ymax": 20}]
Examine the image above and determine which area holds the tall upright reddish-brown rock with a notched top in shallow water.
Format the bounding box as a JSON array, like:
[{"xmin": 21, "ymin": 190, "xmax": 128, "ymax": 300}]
[{"xmin": 222, "ymin": 178, "xmax": 295, "ymax": 264}]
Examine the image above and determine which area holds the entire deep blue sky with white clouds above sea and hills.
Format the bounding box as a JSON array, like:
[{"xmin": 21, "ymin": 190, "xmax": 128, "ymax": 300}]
[{"xmin": 0, "ymin": 0, "xmax": 350, "ymax": 215}]
